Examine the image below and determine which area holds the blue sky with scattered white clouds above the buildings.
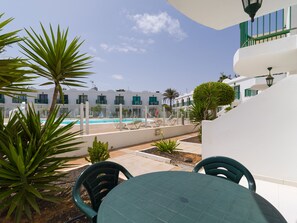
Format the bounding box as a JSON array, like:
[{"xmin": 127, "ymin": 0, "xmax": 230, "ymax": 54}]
[{"xmin": 0, "ymin": 0, "xmax": 239, "ymax": 93}]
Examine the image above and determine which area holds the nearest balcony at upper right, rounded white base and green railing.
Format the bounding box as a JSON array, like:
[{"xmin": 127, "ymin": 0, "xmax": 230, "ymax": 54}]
[{"xmin": 233, "ymin": 6, "xmax": 297, "ymax": 76}]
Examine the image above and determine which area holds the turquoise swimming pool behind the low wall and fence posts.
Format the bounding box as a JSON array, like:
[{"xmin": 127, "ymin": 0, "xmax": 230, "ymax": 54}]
[{"xmin": 51, "ymin": 118, "xmax": 149, "ymax": 125}]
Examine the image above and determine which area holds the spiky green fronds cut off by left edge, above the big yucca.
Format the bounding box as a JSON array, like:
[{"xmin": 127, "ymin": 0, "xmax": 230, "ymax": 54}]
[{"xmin": 0, "ymin": 13, "xmax": 33, "ymax": 96}]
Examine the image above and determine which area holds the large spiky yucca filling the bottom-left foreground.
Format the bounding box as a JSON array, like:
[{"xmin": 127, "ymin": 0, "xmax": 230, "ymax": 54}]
[{"xmin": 0, "ymin": 106, "xmax": 81, "ymax": 222}]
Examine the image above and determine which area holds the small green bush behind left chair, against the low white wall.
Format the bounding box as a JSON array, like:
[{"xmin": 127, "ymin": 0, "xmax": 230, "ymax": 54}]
[{"xmin": 86, "ymin": 136, "xmax": 110, "ymax": 163}]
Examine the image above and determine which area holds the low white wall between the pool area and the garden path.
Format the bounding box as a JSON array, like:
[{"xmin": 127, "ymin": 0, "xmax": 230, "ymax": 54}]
[{"xmin": 67, "ymin": 124, "xmax": 197, "ymax": 156}]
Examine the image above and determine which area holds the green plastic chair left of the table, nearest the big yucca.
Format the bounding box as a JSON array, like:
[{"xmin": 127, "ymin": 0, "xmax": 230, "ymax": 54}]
[{"xmin": 72, "ymin": 161, "xmax": 133, "ymax": 222}]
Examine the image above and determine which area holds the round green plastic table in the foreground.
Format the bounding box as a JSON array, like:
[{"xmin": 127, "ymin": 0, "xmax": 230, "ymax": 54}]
[{"xmin": 97, "ymin": 171, "xmax": 286, "ymax": 223}]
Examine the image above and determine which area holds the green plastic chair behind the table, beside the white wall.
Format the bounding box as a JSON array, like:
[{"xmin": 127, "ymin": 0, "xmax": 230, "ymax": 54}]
[{"xmin": 193, "ymin": 156, "xmax": 256, "ymax": 192}]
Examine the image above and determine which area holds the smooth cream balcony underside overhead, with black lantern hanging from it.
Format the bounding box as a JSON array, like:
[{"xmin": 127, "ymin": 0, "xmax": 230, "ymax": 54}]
[{"xmin": 168, "ymin": 0, "xmax": 297, "ymax": 30}]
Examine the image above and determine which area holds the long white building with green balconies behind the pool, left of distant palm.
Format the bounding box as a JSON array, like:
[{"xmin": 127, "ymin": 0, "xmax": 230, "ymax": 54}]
[{"xmin": 0, "ymin": 88, "xmax": 163, "ymax": 118}]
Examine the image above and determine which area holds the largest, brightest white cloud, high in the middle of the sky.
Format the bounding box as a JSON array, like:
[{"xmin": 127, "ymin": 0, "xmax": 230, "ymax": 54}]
[{"xmin": 129, "ymin": 12, "xmax": 187, "ymax": 40}]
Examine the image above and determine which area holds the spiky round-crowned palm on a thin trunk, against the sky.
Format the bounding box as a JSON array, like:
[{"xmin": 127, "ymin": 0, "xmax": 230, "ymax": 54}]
[{"xmin": 20, "ymin": 24, "xmax": 91, "ymax": 115}]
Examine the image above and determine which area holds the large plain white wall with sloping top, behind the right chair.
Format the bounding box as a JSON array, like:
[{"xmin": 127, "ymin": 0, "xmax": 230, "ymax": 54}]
[{"xmin": 202, "ymin": 75, "xmax": 297, "ymax": 184}]
